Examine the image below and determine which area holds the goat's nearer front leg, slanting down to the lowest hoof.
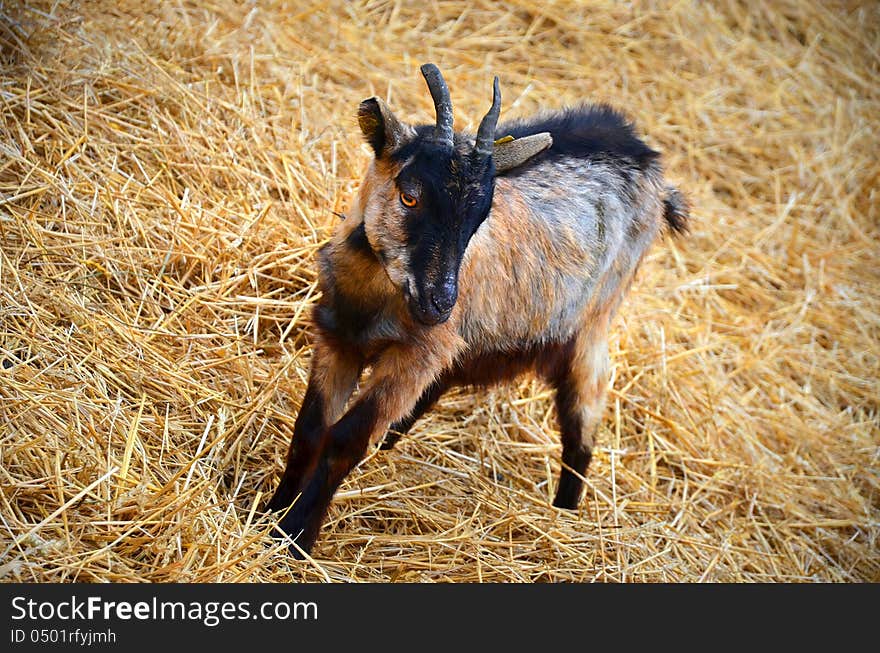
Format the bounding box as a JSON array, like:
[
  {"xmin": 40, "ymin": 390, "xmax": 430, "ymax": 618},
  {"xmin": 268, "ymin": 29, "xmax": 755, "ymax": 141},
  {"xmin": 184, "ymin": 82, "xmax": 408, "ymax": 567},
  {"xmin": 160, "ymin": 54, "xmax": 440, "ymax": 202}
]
[{"xmin": 279, "ymin": 346, "xmax": 454, "ymax": 557}]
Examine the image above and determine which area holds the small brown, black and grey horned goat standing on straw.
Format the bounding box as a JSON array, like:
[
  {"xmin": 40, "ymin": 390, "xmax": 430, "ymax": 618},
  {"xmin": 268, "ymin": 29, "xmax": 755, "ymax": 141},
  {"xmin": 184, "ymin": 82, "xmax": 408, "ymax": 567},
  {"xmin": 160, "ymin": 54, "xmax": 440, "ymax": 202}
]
[{"xmin": 269, "ymin": 64, "xmax": 688, "ymax": 555}]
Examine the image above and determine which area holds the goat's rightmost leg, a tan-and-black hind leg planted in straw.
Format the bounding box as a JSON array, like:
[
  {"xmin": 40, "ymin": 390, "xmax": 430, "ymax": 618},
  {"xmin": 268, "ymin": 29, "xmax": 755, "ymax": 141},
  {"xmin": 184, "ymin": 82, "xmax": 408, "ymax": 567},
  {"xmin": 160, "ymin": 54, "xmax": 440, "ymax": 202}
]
[{"xmin": 552, "ymin": 329, "xmax": 608, "ymax": 510}]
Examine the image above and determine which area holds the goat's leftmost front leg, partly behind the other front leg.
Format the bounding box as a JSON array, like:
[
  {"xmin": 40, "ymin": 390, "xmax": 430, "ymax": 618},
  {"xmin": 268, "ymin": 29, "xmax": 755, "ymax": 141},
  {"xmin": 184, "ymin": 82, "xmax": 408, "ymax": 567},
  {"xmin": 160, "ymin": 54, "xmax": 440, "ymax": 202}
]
[{"xmin": 268, "ymin": 338, "xmax": 362, "ymax": 511}]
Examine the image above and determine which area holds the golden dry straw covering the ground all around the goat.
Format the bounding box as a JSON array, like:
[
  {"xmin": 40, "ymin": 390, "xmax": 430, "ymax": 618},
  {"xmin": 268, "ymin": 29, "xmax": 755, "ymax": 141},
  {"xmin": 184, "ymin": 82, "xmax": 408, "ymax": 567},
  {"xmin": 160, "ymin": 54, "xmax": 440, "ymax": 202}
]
[{"xmin": 0, "ymin": 0, "xmax": 880, "ymax": 582}]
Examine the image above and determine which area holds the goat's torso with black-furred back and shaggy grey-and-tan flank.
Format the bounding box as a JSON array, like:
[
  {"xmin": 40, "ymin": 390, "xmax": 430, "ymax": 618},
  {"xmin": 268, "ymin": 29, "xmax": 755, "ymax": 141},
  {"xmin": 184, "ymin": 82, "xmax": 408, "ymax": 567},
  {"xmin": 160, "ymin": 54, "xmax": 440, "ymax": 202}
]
[{"xmin": 459, "ymin": 106, "xmax": 667, "ymax": 350}]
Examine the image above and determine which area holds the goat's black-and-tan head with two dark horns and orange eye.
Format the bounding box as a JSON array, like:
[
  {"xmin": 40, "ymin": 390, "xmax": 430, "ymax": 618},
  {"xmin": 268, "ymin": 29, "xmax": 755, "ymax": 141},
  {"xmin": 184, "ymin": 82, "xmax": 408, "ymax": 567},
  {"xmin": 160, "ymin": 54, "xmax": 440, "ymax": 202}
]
[{"xmin": 358, "ymin": 64, "xmax": 552, "ymax": 325}]
